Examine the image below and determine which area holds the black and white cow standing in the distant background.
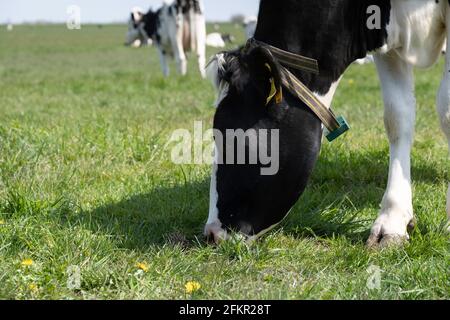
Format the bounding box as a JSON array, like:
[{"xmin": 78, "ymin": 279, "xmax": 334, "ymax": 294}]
[{"xmin": 126, "ymin": 0, "xmax": 206, "ymax": 77}]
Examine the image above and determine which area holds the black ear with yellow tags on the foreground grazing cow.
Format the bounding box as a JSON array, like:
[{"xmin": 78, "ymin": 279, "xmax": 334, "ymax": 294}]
[{"xmin": 247, "ymin": 47, "xmax": 283, "ymax": 105}]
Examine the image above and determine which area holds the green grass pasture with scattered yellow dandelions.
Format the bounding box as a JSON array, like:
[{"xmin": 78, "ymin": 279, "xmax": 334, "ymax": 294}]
[{"xmin": 0, "ymin": 25, "xmax": 450, "ymax": 299}]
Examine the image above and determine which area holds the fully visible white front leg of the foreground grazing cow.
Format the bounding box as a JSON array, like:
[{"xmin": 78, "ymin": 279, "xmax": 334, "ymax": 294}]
[{"xmin": 368, "ymin": 52, "xmax": 416, "ymax": 247}]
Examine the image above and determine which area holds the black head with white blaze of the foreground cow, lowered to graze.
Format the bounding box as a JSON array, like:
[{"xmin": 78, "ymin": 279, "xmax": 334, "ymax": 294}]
[{"xmin": 205, "ymin": 47, "xmax": 322, "ymax": 242}]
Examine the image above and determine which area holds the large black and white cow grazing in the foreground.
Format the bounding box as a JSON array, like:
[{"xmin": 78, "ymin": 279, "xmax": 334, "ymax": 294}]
[{"xmin": 205, "ymin": 0, "xmax": 450, "ymax": 246}]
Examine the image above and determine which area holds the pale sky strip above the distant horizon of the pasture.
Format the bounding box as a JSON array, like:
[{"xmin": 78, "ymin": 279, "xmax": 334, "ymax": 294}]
[{"xmin": 0, "ymin": 0, "xmax": 259, "ymax": 24}]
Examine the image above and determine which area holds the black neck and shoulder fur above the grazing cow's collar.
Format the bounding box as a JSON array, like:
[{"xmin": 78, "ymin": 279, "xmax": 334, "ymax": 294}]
[{"xmin": 255, "ymin": 0, "xmax": 391, "ymax": 94}]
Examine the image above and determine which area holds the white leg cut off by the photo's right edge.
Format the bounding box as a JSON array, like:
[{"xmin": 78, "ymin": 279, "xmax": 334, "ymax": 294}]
[{"xmin": 437, "ymin": 36, "xmax": 450, "ymax": 232}]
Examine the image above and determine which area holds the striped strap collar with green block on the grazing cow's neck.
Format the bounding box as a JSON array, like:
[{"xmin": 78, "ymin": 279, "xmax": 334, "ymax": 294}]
[{"xmin": 246, "ymin": 38, "xmax": 350, "ymax": 142}]
